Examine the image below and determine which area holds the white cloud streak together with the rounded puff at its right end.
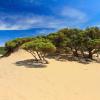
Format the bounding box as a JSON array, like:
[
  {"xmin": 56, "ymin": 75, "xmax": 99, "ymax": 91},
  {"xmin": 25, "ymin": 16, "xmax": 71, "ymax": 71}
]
[{"xmin": 0, "ymin": 7, "xmax": 87, "ymax": 30}]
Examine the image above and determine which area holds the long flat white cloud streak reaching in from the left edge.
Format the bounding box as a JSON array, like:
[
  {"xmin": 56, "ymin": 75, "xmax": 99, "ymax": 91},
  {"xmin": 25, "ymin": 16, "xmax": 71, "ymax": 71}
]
[{"xmin": 0, "ymin": 15, "xmax": 65, "ymax": 30}]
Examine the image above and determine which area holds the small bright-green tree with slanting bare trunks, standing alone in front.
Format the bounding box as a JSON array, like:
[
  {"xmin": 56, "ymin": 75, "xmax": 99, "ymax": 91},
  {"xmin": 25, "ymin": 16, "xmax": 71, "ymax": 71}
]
[{"xmin": 21, "ymin": 38, "xmax": 56, "ymax": 63}]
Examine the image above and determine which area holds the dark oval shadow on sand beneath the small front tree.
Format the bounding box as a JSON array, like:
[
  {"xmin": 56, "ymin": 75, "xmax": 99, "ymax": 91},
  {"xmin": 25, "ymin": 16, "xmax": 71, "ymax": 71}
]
[{"xmin": 15, "ymin": 59, "xmax": 47, "ymax": 68}]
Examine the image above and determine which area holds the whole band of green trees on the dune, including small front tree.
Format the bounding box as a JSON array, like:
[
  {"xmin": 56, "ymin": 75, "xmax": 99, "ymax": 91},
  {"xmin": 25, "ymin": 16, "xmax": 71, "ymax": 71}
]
[{"xmin": 2, "ymin": 27, "xmax": 100, "ymax": 63}]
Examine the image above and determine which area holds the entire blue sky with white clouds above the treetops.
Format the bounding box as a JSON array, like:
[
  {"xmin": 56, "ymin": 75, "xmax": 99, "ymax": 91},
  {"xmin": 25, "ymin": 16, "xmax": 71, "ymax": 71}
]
[{"xmin": 0, "ymin": 0, "xmax": 100, "ymax": 45}]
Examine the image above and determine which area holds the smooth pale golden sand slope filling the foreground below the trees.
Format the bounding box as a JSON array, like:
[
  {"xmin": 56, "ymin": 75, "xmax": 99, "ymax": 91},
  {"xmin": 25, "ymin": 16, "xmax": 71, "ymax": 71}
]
[{"xmin": 0, "ymin": 50, "xmax": 100, "ymax": 100}]
